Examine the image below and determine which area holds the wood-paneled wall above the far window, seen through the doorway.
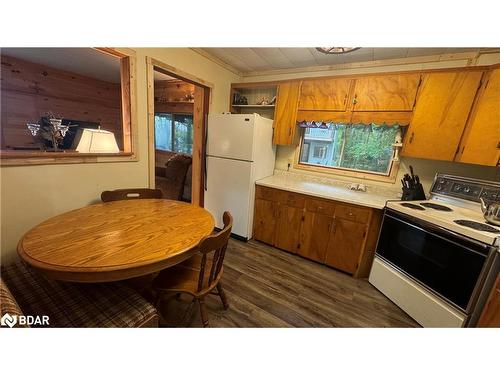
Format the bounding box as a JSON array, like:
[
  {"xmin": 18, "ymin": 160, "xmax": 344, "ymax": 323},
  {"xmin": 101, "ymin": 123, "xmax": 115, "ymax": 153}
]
[{"xmin": 154, "ymin": 80, "xmax": 194, "ymax": 113}]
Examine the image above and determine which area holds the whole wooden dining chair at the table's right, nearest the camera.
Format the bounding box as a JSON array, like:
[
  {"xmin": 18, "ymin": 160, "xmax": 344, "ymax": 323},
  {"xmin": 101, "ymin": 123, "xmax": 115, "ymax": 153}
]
[{"xmin": 153, "ymin": 211, "xmax": 233, "ymax": 327}]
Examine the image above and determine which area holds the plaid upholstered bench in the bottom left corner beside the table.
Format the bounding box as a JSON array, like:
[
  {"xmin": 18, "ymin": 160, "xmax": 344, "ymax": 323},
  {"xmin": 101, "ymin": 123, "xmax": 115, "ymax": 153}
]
[{"xmin": 0, "ymin": 261, "xmax": 158, "ymax": 327}]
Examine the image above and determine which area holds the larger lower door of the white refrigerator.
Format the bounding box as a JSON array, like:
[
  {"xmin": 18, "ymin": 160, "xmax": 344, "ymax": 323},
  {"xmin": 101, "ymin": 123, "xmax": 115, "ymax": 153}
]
[{"xmin": 205, "ymin": 156, "xmax": 252, "ymax": 238}]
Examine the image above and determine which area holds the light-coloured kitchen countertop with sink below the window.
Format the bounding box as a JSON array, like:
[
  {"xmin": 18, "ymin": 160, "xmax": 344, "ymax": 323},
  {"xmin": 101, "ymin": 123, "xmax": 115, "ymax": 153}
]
[{"xmin": 256, "ymin": 170, "xmax": 401, "ymax": 209}]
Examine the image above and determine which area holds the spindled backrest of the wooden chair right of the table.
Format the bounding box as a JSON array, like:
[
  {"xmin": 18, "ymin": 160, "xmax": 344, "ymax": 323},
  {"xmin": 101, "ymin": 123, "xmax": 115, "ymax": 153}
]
[{"xmin": 197, "ymin": 211, "xmax": 233, "ymax": 293}]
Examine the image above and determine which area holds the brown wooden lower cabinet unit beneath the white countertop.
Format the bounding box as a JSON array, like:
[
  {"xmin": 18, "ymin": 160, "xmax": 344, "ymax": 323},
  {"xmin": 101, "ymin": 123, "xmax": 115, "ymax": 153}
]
[{"xmin": 253, "ymin": 186, "xmax": 382, "ymax": 277}]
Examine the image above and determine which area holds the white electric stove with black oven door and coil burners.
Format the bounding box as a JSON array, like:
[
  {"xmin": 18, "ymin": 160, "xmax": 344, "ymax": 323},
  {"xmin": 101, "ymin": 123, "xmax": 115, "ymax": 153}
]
[{"xmin": 369, "ymin": 174, "xmax": 500, "ymax": 327}]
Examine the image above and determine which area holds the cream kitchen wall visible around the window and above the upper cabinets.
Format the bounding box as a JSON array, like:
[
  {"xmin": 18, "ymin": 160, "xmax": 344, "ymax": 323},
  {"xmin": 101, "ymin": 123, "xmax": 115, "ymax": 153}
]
[{"xmin": 243, "ymin": 53, "xmax": 500, "ymax": 192}]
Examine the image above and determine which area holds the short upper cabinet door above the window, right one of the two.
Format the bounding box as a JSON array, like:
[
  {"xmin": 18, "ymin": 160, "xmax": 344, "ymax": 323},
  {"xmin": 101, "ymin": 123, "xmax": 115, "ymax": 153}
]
[{"xmin": 353, "ymin": 73, "xmax": 420, "ymax": 111}]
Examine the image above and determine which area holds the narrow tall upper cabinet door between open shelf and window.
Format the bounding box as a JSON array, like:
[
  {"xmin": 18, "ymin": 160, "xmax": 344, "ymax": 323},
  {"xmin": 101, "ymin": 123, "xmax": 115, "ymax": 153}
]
[{"xmin": 273, "ymin": 82, "xmax": 300, "ymax": 145}]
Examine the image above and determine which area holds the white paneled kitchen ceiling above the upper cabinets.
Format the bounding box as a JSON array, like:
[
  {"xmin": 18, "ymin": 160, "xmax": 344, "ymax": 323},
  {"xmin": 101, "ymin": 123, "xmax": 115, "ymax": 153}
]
[{"xmin": 202, "ymin": 48, "xmax": 480, "ymax": 73}]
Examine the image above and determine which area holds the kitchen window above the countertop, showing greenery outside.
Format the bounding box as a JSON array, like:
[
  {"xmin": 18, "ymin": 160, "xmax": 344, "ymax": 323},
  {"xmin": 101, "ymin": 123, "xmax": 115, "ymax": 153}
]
[{"xmin": 296, "ymin": 123, "xmax": 401, "ymax": 176}]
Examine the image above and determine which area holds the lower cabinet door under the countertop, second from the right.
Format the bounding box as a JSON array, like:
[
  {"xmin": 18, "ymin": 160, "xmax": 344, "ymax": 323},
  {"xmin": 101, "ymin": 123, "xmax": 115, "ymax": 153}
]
[{"xmin": 298, "ymin": 211, "xmax": 333, "ymax": 263}]
